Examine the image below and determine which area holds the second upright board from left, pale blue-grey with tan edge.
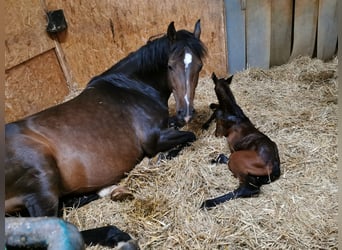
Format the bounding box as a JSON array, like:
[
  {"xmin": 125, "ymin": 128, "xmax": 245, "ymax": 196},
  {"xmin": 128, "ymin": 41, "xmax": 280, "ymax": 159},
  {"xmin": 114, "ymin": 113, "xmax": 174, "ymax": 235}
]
[{"xmin": 246, "ymin": 0, "xmax": 271, "ymax": 68}]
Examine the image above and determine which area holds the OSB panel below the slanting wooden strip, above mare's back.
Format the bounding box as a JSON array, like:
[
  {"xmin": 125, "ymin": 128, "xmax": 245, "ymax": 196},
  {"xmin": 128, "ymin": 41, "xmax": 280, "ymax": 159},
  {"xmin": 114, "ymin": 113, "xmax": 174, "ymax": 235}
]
[{"xmin": 5, "ymin": 49, "xmax": 69, "ymax": 122}]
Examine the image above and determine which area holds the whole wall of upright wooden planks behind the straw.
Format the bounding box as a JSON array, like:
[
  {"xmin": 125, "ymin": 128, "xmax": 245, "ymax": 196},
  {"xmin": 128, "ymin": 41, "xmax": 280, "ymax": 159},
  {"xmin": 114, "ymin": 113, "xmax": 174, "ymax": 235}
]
[{"xmin": 225, "ymin": 0, "xmax": 337, "ymax": 74}]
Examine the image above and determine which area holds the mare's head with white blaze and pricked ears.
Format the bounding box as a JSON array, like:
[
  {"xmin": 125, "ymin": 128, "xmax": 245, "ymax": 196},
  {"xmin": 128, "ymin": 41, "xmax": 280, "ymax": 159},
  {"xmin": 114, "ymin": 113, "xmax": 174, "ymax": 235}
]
[{"xmin": 167, "ymin": 20, "xmax": 206, "ymax": 127}]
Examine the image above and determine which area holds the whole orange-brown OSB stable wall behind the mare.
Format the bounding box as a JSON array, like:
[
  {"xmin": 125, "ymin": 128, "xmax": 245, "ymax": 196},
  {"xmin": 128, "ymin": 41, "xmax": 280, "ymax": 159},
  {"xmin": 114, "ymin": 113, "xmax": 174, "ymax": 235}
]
[{"xmin": 5, "ymin": 0, "xmax": 227, "ymax": 122}]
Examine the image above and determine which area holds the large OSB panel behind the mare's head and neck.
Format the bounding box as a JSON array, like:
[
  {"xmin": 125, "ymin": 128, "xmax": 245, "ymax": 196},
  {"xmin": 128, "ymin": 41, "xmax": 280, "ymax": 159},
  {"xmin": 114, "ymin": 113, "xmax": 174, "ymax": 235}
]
[{"xmin": 46, "ymin": 0, "xmax": 227, "ymax": 87}]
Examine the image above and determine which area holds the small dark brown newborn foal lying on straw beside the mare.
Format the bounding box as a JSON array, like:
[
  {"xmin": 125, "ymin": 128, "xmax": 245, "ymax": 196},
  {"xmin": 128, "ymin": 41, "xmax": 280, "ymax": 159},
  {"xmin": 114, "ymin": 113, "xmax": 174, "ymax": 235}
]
[{"xmin": 201, "ymin": 73, "xmax": 280, "ymax": 208}]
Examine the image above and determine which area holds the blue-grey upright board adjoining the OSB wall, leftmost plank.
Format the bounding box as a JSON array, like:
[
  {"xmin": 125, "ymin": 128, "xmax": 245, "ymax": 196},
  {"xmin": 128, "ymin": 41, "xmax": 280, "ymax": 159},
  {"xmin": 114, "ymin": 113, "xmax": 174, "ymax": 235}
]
[{"xmin": 224, "ymin": 0, "xmax": 246, "ymax": 74}]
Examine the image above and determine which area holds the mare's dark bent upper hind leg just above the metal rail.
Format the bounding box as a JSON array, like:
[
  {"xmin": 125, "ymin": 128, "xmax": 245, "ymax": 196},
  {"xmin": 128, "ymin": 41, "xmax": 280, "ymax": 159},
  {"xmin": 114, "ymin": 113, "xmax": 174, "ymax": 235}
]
[{"xmin": 5, "ymin": 150, "xmax": 60, "ymax": 217}]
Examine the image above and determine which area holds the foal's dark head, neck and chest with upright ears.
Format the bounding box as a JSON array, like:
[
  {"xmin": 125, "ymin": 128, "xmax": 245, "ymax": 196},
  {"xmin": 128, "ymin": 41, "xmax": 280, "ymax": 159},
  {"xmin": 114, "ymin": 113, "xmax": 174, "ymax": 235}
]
[{"xmin": 211, "ymin": 73, "xmax": 248, "ymax": 137}]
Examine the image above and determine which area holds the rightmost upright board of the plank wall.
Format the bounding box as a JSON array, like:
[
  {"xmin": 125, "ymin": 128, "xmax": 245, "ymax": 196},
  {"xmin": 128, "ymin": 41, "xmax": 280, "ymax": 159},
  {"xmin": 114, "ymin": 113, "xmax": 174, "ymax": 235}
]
[{"xmin": 317, "ymin": 0, "xmax": 337, "ymax": 60}]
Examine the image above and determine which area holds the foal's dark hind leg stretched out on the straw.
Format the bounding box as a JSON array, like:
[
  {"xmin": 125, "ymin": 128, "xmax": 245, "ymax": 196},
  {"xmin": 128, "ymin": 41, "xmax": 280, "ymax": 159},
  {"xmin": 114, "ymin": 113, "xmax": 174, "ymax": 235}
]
[{"xmin": 201, "ymin": 184, "xmax": 260, "ymax": 209}]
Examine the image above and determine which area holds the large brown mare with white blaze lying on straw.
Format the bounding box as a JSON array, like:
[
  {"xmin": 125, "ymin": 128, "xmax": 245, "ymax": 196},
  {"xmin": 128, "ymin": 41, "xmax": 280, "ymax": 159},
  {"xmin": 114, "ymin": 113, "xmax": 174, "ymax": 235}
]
[{"xmin": 5, "ymin": 21, "xmax": 206, "ymax": 216}]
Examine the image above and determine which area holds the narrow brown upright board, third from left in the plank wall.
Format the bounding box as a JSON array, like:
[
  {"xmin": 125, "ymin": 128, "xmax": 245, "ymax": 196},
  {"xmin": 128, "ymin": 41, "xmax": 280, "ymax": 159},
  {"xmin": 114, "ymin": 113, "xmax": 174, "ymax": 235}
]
[{"xmin": 270, "ymin": 0, "xmax": 293, "ymax": 66}]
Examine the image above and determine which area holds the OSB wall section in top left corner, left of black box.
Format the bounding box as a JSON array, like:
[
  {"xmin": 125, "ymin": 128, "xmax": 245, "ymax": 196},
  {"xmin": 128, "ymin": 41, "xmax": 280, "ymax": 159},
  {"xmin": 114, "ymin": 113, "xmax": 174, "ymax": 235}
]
[{"xmin": 5, "ymin": 0, "xmax": 54, "ymax": 69}]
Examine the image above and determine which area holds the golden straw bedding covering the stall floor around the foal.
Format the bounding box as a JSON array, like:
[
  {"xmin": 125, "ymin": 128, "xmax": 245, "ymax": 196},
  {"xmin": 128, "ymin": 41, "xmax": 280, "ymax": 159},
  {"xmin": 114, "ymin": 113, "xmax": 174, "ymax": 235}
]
[{"xmin": 64, "ymin": 57, "xmax": 338, "ymax": 249}]
